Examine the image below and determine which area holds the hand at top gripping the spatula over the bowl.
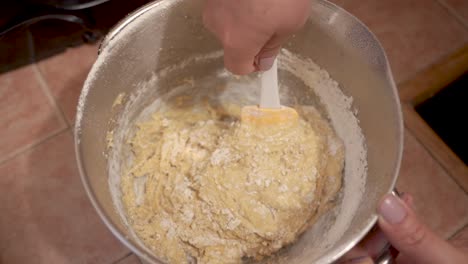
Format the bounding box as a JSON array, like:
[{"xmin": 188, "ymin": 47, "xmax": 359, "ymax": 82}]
[{"xmin": 203, "ymin": 0, "xmax": 310, "ymax": 75}]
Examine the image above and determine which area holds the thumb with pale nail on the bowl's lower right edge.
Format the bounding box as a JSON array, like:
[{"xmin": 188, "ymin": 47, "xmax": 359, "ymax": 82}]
[{"xmin": 378, "ymin": 194, "xmax": 460, "ymax": 264}]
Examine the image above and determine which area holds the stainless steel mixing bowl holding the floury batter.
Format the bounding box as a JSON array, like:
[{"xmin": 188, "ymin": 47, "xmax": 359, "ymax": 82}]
[{"xmin": 75, "ymin": 0, "xmax": 403, "ymax": 263}]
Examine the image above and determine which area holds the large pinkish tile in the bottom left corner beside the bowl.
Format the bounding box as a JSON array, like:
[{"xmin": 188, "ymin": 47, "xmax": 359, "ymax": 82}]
[{"xmin": 0, "ymin": 130, "xmax": 129, "ymax": 264}]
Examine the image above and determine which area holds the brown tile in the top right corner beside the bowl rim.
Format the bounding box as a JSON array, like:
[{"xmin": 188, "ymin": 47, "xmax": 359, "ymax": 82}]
[{"xmin": 336, "ymin": 0, "xmax": 468, "ymax": 82}]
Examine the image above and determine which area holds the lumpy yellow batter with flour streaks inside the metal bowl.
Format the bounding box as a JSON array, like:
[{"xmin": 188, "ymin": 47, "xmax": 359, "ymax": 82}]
[{"xmin": 121, "ymin": 97, "xmax": 344, "ymax": 263}]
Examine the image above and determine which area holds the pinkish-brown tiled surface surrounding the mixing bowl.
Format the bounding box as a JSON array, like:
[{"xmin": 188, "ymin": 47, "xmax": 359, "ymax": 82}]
[{"xmin": 0, "ymin": 0, "xmax": 468, "ymax": 264}]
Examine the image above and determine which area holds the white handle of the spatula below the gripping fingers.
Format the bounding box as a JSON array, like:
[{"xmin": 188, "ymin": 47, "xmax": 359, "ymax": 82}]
[{"xmin": 260, "ymin": 59, "xmax": 281, "ymax": 108}]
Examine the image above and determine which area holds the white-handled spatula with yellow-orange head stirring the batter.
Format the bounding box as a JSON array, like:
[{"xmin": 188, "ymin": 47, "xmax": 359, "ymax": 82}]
[{"xmin": 241, "ymin": 60, "xmax": 298, "ymax": 126}]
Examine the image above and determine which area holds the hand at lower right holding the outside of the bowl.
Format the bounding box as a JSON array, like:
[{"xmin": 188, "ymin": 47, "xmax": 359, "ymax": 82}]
[{"xmin": 338, "ymin": 195, "xmax": 468, "ymax": 264}]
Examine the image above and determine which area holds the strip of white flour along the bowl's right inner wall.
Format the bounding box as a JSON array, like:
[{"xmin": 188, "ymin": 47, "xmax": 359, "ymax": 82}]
[{"xmin": 279, "ymin": 49, "xmax": 367, "ymax": 256}]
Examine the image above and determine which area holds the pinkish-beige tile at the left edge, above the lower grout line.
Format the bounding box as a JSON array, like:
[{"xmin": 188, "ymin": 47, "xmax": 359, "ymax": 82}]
[{"xmin": 0, "ymin": 66, "xmax": 66, "ymax": 162}]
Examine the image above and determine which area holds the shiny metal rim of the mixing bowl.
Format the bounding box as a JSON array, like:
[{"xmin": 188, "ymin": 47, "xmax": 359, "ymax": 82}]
[{"xmin": 74, "ymin": 0, "xmax": 404, "ymax": 264}]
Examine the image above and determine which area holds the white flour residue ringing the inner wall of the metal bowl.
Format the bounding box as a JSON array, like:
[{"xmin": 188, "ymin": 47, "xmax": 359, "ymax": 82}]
[{"xmin": 103, "ymin": 50, "xmax": 367, "ymax": 260}]
